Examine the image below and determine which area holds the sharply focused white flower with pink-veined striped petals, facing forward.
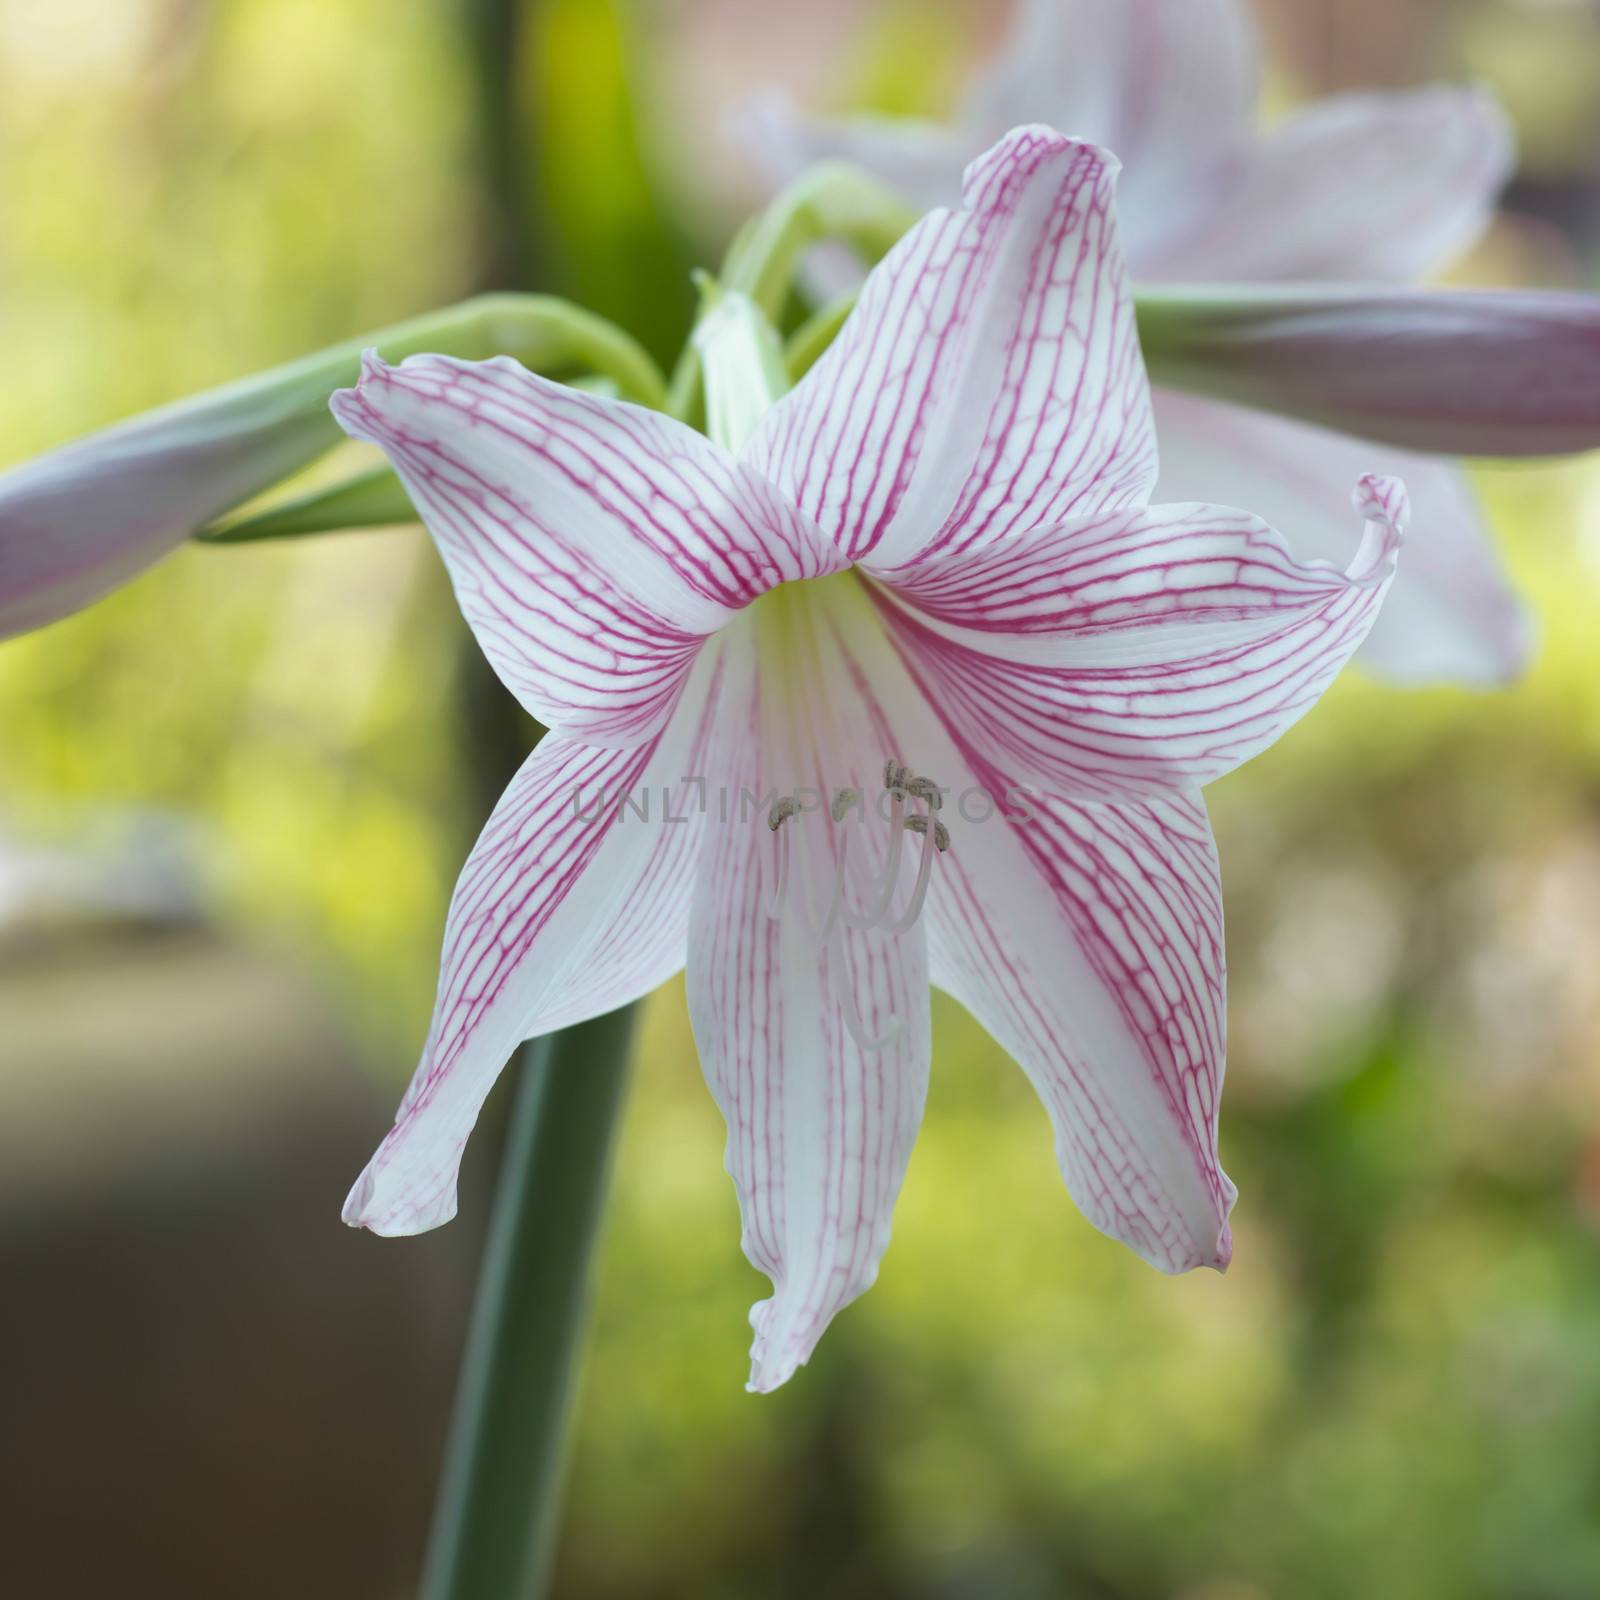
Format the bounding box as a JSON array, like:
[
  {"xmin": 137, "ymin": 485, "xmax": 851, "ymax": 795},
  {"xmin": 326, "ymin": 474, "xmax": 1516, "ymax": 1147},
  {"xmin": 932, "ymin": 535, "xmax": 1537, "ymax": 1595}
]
[{"xmin": 334, "ymin": 128, "xmax": 1405, "ymax": 1390}]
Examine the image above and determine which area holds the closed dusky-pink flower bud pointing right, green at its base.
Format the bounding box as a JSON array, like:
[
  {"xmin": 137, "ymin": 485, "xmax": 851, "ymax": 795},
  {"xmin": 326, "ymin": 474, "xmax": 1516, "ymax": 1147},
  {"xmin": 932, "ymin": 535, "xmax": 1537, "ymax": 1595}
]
[{"xmin": 1139, "ymin": 288, "xmax": 1600, "ymax": 456}]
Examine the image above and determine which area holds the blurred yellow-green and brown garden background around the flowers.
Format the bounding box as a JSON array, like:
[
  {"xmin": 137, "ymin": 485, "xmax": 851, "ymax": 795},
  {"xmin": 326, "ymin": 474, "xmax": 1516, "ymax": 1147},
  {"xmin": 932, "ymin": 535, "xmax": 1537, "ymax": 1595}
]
[{"xmin": 0, "ymin": 0, "xmax": 1600, "ymax": 1600}]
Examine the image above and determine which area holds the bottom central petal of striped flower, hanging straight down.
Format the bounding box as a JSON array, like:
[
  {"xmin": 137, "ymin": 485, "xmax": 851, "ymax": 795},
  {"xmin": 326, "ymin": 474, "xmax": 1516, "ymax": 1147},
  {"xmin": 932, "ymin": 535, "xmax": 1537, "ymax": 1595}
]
[{"xmin": 688, "ymin": 598, "xmax": 930, "ymax": 1392}]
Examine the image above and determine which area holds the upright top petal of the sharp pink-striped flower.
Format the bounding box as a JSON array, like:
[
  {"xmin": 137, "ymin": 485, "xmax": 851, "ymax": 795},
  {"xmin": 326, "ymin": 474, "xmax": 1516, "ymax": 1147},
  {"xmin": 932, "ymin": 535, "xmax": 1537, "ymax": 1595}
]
[{"xmin": 746, "ymin": 128, "xmax": 1155, "ymax": 566}]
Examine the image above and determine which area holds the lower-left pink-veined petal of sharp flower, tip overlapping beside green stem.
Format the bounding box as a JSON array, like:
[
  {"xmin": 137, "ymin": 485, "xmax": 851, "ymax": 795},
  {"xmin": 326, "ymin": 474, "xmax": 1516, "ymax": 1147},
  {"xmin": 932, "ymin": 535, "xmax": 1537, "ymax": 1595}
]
[{"xmin": 344, "ymin": 645, "xmax": 722, "ymax": 1234}]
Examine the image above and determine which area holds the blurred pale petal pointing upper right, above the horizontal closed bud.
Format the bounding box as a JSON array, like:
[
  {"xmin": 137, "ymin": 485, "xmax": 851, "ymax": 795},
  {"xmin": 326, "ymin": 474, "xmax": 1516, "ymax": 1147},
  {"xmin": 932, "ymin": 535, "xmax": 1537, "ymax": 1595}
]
[{"xmin": 1145, "ymin": 86, "xmax": 1515, "ymax": 283}]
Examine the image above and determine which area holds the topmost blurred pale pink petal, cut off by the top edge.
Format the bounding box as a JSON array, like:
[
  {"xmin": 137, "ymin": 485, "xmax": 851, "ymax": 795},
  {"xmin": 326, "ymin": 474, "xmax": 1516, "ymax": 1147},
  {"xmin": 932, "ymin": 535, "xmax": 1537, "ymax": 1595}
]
[{"xmin": 960, "ymin": 0, "xmax": 1261, "ymax": 272}]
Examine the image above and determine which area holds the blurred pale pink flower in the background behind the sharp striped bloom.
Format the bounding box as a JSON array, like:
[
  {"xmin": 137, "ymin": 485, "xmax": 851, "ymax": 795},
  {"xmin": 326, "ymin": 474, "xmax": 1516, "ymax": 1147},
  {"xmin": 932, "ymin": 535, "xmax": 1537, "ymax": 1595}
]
[{"xmin": 739, "ymin": 0, "xmax": 1548, "ymax": 683}]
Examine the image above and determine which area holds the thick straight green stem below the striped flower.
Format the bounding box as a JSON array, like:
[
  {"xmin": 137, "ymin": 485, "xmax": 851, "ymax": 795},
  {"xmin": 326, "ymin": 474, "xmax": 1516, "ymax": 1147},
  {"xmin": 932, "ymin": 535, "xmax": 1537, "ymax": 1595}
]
[{"xmin": 421, "ymin": 1008, "xmax": 634, "ymax": 1600}]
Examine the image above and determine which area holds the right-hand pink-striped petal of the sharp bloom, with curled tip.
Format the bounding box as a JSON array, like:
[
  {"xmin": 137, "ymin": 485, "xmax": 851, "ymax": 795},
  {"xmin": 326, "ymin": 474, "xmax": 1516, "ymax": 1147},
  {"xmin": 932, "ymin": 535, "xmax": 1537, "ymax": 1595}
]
[{"xmin": 883, "ymin": 477, "xmax": 1406, "ymax": 798}]
